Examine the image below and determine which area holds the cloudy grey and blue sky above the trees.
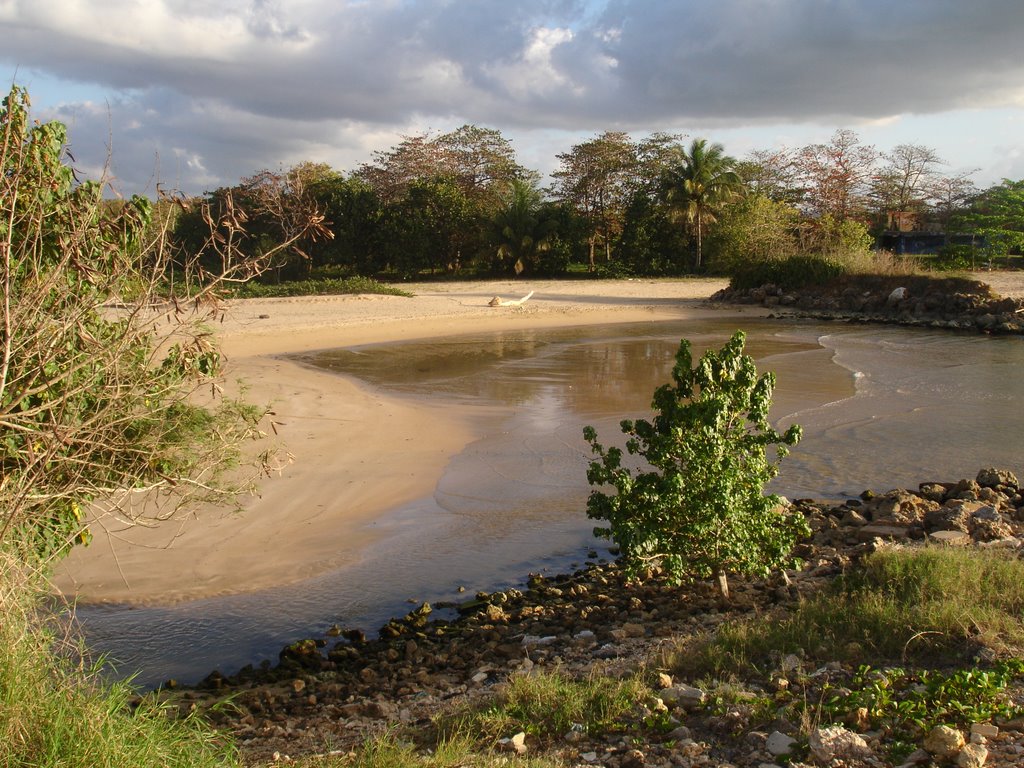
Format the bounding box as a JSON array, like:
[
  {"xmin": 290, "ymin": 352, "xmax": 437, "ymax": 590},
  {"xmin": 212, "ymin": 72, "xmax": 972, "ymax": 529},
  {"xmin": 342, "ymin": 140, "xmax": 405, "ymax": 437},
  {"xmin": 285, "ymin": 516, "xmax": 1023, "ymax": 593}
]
[{"xmin": 0, "ymin": 0, "xmax": 1024, "ymax": 195}]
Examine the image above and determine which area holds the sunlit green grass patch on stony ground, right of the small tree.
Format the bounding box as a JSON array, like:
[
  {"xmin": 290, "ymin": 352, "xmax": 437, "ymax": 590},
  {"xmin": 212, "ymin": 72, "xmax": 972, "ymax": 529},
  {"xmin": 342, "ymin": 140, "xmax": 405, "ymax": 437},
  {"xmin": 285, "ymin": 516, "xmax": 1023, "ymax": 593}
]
[{"xmin": 670, "ymin": 548, "xmax": 1024, "ymax": 676}]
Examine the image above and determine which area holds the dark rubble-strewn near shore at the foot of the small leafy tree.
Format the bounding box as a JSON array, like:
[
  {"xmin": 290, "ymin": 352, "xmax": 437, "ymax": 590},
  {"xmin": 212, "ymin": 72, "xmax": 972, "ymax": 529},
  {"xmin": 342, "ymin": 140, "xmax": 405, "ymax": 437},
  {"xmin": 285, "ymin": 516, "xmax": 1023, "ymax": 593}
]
[{"xmin": 162, "ymin": 469, "xmax": 1024, "ymax": 768}]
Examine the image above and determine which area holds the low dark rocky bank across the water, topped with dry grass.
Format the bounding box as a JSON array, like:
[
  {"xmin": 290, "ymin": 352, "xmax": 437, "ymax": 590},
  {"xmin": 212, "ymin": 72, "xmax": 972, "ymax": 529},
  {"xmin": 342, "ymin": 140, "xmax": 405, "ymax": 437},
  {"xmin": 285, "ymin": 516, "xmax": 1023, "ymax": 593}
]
[{"xmin": 711, "ymin": 274, "xmax": 1024, "ymax": 335}]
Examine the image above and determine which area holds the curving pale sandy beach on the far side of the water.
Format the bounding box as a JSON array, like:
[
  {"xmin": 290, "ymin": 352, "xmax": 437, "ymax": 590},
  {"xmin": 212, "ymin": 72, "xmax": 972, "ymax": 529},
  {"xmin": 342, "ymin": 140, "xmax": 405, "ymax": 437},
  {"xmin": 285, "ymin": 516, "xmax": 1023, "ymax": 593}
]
[{"xmin": 55, "ymin": 280, "xmax": 741, "ymax": 605}]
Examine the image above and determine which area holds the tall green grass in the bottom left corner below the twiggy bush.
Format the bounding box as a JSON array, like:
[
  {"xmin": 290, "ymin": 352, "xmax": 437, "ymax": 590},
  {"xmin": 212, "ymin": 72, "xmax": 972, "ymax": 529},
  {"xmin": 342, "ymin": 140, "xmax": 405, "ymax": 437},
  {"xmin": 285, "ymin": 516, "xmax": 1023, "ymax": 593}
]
[{"xmin": 0, "ymin": 553, "xmax": 238, "ymax": 768}]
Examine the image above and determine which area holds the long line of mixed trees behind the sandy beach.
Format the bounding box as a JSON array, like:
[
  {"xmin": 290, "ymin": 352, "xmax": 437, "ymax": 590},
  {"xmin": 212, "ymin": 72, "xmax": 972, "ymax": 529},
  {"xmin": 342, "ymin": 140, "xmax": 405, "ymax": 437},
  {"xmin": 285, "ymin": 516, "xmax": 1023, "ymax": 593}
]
[{"xmin": 174, "ymin": 125, "xmax": 1024, "ymax": 281}]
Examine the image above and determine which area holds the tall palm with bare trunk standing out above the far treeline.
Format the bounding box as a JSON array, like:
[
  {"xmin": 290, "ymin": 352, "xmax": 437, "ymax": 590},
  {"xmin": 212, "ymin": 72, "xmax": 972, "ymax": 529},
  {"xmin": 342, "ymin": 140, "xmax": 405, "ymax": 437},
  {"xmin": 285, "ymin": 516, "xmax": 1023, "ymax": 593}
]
[{"xmin": 665, "ymin": 138, "xmax": 743, "ymax": 269}]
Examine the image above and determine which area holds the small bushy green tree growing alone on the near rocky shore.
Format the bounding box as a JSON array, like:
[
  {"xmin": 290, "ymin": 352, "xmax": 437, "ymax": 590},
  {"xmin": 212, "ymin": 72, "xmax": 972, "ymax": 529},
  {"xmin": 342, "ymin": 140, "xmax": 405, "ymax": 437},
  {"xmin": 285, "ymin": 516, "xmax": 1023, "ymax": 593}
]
[{"xmin": 584, "ymin": 331, "xmax": 810, "ymax": 599}]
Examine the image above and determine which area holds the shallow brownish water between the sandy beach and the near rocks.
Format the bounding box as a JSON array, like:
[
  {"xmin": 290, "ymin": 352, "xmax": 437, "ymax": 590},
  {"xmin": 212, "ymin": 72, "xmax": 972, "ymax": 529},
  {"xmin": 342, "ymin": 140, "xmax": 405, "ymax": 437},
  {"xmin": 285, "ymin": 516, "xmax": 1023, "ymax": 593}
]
[{"xmin": 79, "ymin": 321, "xmax": 1024, "ymax": 685}]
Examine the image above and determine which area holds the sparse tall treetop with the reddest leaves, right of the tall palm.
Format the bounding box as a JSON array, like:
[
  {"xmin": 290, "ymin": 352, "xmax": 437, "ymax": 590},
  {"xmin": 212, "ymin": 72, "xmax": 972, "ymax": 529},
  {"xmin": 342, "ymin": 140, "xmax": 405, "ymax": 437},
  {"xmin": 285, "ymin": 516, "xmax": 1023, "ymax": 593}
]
[{"xmin": 796, "ymin": 129, "xmax": 879, "ymax": 221}]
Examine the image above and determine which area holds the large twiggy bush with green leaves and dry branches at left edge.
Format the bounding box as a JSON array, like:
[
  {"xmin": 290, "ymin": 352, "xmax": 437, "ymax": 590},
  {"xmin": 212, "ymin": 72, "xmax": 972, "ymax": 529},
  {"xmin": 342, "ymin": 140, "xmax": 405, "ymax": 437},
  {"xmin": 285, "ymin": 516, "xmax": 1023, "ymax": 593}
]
[{"xmin": 0, "ymin": 87, "xmax": 301, "ymax": 558}]
